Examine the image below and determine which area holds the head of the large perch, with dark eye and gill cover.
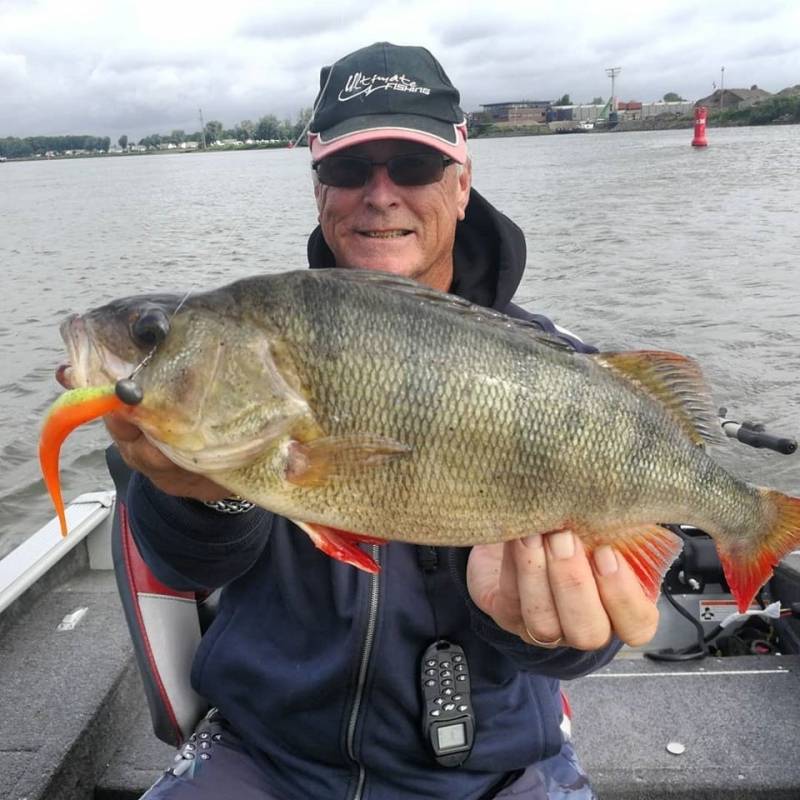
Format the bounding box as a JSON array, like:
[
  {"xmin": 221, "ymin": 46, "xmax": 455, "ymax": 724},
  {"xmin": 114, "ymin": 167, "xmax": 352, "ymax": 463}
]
[{"xmin": 61, "ymin": 292, "xmax": 308, "ymax": 473}]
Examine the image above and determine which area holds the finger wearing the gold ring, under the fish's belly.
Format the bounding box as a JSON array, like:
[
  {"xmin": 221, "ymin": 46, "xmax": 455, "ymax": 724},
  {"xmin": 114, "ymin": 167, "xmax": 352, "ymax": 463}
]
[{"xmin": 513, "ymin": 534, "xmax": 564, "ymax": 644}]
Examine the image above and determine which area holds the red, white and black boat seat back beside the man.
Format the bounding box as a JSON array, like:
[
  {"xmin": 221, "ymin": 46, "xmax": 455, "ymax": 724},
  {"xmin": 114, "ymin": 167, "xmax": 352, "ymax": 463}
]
[{"xmin": 106, "ymin": 445, "xmax": 217, "ymax": 747}]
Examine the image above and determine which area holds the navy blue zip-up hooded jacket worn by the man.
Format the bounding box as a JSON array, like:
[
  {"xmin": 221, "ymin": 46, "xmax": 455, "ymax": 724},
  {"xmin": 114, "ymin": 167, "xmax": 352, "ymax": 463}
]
[{"xmin": 128, "ymin": 192, "xmax": 619, "ymax": 800}]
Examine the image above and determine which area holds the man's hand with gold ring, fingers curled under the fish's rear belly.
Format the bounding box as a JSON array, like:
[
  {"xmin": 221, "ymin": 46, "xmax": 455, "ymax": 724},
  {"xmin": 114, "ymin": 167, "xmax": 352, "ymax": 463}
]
[{"xmin": 467, "ymin": 531, "xmax": 658, "ymax": 650}]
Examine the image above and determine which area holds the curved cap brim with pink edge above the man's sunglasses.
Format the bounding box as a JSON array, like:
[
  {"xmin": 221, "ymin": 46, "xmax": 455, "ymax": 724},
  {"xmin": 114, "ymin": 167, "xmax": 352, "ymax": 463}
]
[{"xmin": 308, "ymin": 114, "xmax": 467, "ymax": 164}]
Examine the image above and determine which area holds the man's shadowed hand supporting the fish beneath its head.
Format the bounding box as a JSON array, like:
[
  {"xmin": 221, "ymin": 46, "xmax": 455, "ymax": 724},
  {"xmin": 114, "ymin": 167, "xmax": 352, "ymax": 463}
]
[{"xmin": 104, "ymin": 414, "xmax": 230, "ymax": 500}]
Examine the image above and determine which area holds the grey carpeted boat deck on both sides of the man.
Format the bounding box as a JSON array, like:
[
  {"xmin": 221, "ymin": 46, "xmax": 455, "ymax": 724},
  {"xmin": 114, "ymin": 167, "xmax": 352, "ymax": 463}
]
[{"xmin": 0, "ymin": 547, "xmax": 800, "ymax": 800}]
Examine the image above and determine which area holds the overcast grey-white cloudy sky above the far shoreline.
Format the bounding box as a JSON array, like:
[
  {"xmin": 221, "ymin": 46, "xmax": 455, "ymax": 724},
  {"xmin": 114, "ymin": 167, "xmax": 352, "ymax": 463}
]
[{"xmin": 0, "ymin": 0, "xmax": 800, "ymax": 141}]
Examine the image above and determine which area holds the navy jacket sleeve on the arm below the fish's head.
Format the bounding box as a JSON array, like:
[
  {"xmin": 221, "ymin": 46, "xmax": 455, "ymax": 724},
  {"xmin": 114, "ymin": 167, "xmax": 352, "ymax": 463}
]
[{"xmin": 127, "ymin": 473, "xmax": 273, "ymax": 591}]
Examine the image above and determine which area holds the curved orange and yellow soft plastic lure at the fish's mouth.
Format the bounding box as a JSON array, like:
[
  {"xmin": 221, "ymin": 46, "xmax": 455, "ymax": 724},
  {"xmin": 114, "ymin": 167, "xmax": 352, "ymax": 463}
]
[{"xmin": 39, "ymin": 385, "xmax": 125, "ymax": 536}]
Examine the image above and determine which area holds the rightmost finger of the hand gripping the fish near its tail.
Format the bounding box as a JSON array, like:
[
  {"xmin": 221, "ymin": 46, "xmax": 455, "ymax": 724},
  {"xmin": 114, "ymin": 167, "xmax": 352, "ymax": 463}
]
[{"xmin": 592, "ymin": 545, "xmax": 658, "ymax": 647}]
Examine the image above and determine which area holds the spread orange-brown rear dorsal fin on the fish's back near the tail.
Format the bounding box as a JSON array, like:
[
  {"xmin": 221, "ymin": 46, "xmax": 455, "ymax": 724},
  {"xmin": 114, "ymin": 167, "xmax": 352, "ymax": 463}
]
[{"xmin": 590, "ymin": 350, "xmax": 722, "ymax": 445}]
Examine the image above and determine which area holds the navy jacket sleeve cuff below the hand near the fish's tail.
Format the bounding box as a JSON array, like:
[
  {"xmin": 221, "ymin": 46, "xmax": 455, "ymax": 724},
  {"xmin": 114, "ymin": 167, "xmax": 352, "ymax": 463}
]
[{"xmin": 446, "ymin": 547, "xmax": 622, "ymax": 680}]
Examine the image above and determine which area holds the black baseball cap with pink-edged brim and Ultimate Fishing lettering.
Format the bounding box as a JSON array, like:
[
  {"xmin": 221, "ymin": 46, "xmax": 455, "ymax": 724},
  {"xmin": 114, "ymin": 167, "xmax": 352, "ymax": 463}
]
[{"xmin": 308, "ymin": 42, "xmax": 467, "ymax": 164}]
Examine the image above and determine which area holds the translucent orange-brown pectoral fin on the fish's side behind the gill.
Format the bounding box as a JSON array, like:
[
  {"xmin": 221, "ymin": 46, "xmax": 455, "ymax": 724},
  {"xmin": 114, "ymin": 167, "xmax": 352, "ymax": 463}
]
[{"xmin": 284, "ymin": 434, "xmax": 412, "ymax": 488}]
